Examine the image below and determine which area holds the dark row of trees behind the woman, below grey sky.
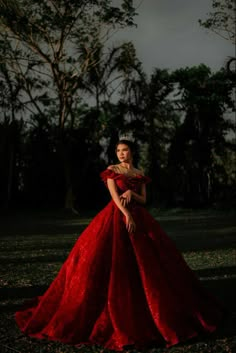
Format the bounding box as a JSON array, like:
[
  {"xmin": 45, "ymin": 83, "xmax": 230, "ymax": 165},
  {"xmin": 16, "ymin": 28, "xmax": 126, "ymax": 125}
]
[{"xmin": 0, "ymin": 0, "xmax": 236, "ymax": 212}]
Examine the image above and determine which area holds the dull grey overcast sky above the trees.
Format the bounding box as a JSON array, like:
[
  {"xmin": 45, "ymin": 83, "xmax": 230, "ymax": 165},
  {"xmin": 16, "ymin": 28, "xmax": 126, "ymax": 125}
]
[{"xmin": 114, "ymin": 0, "xmax": 235, "ymax": 73}]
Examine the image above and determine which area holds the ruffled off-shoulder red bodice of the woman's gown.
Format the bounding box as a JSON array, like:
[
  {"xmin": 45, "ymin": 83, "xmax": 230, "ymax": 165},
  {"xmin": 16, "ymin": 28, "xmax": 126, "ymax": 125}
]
[{"xmin": 100, "ymin": 169, "xmax": 151, "ymax": 193}]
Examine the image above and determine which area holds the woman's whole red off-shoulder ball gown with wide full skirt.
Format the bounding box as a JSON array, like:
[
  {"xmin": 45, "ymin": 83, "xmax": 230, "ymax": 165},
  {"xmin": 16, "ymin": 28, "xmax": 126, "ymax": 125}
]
[{"xmin": 16, "ymin": 169, "xmax": 222, "ymax": 350}]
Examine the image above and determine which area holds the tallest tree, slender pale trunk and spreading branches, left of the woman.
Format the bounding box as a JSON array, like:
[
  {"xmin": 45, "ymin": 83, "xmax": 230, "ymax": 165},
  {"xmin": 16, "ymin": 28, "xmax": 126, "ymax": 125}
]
[{"xmin": 0, "ymin": 0, "xmax": 135, "ymax": 208}]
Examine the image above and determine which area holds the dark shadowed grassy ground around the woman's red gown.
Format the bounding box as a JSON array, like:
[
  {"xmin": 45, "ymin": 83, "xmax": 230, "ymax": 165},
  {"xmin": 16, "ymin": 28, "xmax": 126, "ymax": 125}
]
[{"xmin": 0, "ymin": 210, "xmax": 236, "ymax": 353}]
